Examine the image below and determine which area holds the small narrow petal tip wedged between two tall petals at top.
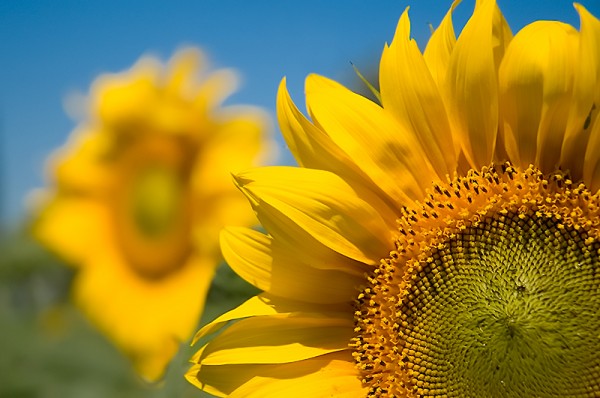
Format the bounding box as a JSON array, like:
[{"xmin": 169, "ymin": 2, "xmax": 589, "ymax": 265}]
[{"xmin": 423, "ymin": 0, "xmax": 460, "ymax": 86}]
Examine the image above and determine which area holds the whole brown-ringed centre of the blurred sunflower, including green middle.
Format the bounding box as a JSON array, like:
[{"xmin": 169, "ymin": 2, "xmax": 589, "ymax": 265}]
[{"xmin": 112, "ymin": 137, "xmax": 193, "ymax": 279}]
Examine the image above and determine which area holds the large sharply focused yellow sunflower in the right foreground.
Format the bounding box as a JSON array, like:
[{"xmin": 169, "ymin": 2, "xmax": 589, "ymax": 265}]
[{"xmin": 187, "ymin": 0, "xmax": 600, "ymax": 398}]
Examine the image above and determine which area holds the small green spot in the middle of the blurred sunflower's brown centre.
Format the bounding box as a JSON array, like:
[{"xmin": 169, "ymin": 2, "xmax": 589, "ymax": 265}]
[{"xmin": 131, "ymin": 165, "xmax": 183, "ymax": 239}]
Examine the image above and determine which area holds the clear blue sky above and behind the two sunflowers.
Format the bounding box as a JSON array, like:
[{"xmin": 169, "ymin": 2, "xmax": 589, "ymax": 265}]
[{"xmin": 0, "ymin": 0, "xmax": 600, "ymax": 224}]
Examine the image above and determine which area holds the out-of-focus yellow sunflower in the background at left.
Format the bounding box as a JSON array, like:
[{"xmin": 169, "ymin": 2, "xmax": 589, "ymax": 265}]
[{"xmin": 34, "ymin": 49, "xmax": 268, "ymax": 380}]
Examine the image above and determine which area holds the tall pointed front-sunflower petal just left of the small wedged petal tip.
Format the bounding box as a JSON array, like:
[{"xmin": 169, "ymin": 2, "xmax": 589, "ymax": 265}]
[{"xmin": 379, "ymin": 9, "xmax": 456, "ymax": 178}]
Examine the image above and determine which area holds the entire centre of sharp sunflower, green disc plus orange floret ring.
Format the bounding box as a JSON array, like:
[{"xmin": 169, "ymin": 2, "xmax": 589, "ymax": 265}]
[{"xmin": 355, "ymin": 162, "xmax": 600, "ymax": 398}]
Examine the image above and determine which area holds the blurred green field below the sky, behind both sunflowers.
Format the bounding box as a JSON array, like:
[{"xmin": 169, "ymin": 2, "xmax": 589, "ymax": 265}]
[{"xmin": 0, "ymin": 230, "xmax": 256, "ymax": 398}]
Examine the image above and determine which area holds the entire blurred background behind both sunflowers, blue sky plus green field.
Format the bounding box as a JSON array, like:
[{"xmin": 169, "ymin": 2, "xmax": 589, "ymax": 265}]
[{"xmin": 0, "ymin": 0, "xmax": 600, "ymax": 398}]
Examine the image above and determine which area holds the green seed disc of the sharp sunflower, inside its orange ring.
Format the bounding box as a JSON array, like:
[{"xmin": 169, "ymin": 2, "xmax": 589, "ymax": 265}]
[{"xmin": 398, "ymin": 210, "xmax": 600, "ymax": 397}]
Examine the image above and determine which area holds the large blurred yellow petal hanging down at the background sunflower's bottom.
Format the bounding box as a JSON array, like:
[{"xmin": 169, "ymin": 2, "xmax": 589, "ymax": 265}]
[{"xmin": 74, "ymin": 247, "xmax": 216, "ymax": 380}]
